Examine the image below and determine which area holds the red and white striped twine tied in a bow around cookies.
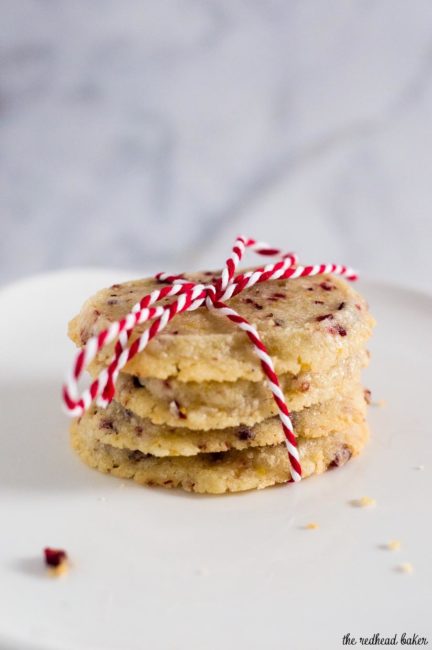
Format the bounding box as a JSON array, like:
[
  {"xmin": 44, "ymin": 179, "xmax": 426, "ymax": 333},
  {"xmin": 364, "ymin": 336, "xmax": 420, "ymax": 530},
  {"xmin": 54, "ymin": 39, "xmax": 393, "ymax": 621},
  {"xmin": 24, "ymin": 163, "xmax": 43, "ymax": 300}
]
[{"xmin": 63, "ymin": 237, "xmax": 357, "ymax": 481}]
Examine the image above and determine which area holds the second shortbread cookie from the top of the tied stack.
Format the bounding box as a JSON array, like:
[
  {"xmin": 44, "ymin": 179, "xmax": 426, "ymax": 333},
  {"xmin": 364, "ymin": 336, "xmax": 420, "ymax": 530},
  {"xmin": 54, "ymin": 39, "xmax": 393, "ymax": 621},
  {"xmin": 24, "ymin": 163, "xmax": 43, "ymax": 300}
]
[{"xmin": 112, "ymin": 350, "xmax": 369, "ymax": 430}]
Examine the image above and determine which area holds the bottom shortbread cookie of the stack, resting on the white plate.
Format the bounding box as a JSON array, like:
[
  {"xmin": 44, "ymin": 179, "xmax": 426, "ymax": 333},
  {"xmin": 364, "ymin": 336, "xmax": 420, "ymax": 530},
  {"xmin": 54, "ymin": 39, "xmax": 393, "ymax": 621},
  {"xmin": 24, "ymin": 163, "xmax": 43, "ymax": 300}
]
[{"xmin": 72, "ymin": 423, "xmax": 368, "ymax": 494}]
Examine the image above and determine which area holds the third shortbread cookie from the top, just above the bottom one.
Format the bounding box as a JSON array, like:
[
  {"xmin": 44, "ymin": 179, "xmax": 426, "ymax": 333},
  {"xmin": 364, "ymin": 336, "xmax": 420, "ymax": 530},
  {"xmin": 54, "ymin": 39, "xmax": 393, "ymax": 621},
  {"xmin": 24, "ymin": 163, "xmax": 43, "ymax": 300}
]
[{"xmin": 74, "ymin": 385, "xmax": 367, "ymax": 456}]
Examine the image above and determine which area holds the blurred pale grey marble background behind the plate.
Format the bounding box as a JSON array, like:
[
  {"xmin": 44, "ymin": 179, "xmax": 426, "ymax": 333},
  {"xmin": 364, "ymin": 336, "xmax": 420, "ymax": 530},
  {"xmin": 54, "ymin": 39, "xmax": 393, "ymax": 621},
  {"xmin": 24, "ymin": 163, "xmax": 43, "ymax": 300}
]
[{"xmin": 0, "ymin": 0, "xmax": 432, "ymax": 290}]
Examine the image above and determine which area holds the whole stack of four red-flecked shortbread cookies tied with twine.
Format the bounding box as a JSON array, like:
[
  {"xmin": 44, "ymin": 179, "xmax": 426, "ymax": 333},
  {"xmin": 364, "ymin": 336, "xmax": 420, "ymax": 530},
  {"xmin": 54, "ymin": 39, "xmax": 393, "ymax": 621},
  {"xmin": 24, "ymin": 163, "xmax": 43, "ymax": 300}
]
[{"xmin": 69, "ymin": 272, "xmax": 374, "ymax": 494}]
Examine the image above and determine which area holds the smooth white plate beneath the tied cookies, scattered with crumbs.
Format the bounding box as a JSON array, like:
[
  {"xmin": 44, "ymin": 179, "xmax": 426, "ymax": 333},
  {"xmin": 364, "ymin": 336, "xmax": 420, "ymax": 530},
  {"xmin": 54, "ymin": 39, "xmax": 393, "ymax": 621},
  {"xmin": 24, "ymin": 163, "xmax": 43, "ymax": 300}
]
[{"xmin": 0, "ymin": 271, "xmax": 432, "ymax": 650}]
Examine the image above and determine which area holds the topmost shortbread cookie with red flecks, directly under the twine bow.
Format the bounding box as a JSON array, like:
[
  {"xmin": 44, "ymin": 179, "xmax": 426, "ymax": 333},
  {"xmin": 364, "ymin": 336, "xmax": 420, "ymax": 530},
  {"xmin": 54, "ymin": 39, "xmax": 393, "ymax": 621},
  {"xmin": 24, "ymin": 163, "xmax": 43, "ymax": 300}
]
[{"xmin": 69, "ymin": 272, "xmax": 374, "ymax": 382}]
